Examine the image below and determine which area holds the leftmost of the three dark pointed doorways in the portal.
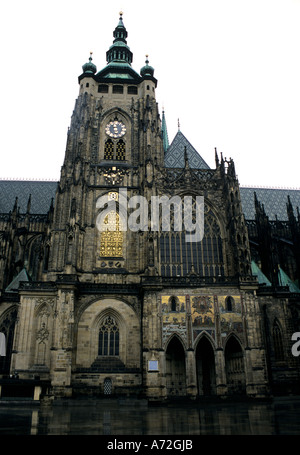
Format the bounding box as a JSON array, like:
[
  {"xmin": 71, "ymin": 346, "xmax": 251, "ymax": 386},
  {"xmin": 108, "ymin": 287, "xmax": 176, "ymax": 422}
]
[{"xmin": 166, "ymin": 336, "xmax": 186, "ymax": 397}]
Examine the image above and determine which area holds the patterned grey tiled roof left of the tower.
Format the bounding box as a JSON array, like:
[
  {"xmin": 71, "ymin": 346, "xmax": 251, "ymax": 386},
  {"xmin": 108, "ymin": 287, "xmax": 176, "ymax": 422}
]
[{"xmin": 0, "ymin": 180, "xmax": 57, "ymax": 214}]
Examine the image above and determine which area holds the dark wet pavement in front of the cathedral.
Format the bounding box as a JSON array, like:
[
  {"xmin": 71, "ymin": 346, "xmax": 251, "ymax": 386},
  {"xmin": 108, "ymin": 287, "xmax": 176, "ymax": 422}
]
[{"xmin": 0, "ymin": 397, "xmax": 300, "ymax": 435}]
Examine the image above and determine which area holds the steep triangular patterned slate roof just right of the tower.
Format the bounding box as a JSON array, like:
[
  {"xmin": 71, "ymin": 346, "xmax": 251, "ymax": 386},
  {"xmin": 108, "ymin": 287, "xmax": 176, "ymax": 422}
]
[{"xmin": 165, "ymin": 130, "xmax": 210, "ymax": 169}]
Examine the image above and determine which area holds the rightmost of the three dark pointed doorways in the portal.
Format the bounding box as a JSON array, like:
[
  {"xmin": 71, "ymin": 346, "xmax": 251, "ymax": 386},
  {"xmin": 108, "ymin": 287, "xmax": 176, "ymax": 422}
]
[{"xmin": 225, "ymin": 336, "xmax": 246, "ymax": 395}]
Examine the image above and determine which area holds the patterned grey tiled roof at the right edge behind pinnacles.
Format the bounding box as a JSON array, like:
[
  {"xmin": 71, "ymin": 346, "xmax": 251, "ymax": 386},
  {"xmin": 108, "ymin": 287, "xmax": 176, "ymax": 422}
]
[{"xmin": 240, "ymin": 187, "xmax": 300, "ymax": 221}]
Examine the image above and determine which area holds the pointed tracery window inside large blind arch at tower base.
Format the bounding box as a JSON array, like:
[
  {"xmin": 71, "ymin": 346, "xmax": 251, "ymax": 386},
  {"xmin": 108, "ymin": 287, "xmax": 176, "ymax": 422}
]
[{"xmin": 98, "ymin": 316, "xmax": 120, "ymax": 356}]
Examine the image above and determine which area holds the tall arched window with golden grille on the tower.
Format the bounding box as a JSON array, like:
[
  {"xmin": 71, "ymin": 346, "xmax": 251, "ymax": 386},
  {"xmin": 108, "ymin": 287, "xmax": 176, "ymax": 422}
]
[{"xmin": 100, "ymin": 211, "xmax": 124, "ymax": 257}]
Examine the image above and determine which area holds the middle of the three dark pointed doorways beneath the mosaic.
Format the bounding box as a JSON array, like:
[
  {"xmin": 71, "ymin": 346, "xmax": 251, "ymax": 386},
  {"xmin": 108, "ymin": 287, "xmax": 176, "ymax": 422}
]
[{"xmin": 196, "ymin": 336, "xmax": 216, "ymax": 395}]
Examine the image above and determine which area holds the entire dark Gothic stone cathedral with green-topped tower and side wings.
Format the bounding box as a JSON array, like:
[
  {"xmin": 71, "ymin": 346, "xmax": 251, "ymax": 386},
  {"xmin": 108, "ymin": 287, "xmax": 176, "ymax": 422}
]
[{"xmin": 0, "ymin": 13, "xmax": 300, "ymax": 402}]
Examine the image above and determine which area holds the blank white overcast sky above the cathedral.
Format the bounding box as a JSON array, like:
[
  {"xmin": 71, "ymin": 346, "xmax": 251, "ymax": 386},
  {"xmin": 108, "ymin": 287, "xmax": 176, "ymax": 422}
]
[{"xmin": 0, "ymin": 0, "xmax": 300, "ymax": 188}]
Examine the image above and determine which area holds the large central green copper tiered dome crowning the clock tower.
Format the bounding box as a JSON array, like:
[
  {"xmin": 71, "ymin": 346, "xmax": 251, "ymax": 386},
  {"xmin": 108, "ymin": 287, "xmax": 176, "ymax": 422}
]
[{"xmin": 96, "ymin": 12, "xmax": 141, "ymax": 83}]
